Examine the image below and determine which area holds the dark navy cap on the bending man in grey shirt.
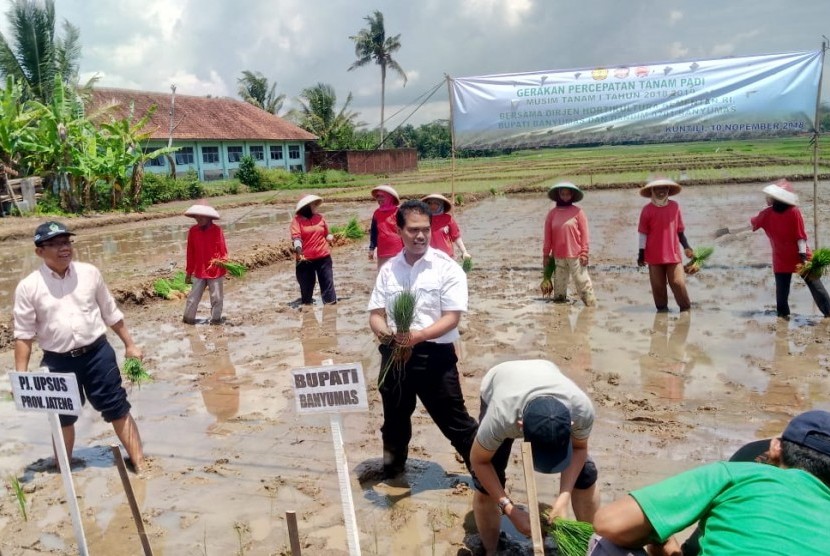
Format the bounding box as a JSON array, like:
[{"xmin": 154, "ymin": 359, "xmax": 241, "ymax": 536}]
[{"xmin": 522, "ymin": 396, "xmax": 573, "ymax": 473}]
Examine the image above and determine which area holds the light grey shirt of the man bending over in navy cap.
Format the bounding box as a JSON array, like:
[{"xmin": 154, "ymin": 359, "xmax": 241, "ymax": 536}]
[{"xmin": 476, "ymin": 359, "xmax": 594, "ymax": 452}]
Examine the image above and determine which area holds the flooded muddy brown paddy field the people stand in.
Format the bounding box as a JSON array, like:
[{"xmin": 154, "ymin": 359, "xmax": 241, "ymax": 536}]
[{"xmin": 0, "ymin": 184, "xmax": 830, "ymax": 555}]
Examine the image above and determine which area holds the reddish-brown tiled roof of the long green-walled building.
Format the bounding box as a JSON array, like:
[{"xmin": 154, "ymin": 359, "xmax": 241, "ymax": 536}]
[{"xmin": 90, "ymin": 88, "xmax": 317, "ymax": 141}]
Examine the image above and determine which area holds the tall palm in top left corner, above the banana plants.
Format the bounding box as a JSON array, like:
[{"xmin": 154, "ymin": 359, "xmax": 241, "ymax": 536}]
[{"xmin": 0, "ymin": 0, "xmax": 81, "ymax": 104}]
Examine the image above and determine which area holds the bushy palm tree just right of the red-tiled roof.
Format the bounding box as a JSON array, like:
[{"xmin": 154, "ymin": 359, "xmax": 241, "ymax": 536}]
[{"xmin": 298, "ymin": 83, "xmax": 364, "ymax": 149}]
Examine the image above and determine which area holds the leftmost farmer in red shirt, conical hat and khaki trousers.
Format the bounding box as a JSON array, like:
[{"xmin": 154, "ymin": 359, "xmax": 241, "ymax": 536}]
[{"xmin": 182, "ymin": 205, "xmax": 228, "ymax": 324}]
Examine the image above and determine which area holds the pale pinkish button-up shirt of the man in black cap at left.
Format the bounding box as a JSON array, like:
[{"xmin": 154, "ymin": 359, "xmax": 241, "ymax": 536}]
[{"xmin": 14, "ymin": 262, "xmax": 124, "ymax": 353}]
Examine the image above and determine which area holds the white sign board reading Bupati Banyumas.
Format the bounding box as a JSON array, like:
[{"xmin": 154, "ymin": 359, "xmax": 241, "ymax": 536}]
[{"xmin": 291, "ymin": 363, "xmax": 369, "ymax": 413}]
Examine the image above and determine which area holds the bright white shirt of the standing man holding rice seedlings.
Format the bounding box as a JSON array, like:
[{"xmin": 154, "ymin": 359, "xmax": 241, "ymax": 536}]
[{"xmin": 369, "ymin": 247, "xmax": 467, "ymax": 344}]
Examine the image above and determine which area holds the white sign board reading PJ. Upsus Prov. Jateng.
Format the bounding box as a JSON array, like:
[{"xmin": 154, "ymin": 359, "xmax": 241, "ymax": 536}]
[{"xmin": 9, "ymin": 372, "xmax": 82, "ymax": 415}]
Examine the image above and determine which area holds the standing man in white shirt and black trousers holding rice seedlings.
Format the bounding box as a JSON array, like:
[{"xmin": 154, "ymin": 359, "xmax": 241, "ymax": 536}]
[{"xmin": 369, "ymin": 201, "xmax": 477, "ymax": 478}]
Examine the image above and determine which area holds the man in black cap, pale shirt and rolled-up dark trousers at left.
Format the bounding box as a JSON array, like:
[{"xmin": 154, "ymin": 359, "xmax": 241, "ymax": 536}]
[{"xmin": 14, "ymin": 222, "xmax": 144, "ymax": 472}]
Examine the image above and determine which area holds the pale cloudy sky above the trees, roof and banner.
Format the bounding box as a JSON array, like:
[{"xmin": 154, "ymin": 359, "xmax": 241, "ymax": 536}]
[{"xmin": 0, "ymin": 0, "xmax": 830, "ymax": 129}]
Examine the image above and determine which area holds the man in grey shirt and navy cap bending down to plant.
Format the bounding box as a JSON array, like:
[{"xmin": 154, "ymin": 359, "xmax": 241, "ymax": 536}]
[{"xmin": 470, "ymin": 359, "xmax": 599, "ymax": 555}]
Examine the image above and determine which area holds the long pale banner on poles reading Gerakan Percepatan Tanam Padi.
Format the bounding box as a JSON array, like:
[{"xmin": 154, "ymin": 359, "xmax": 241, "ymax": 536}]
[{"xmin": 450, "ymin": 51, "xmax": 823, "ymax": 149}]
